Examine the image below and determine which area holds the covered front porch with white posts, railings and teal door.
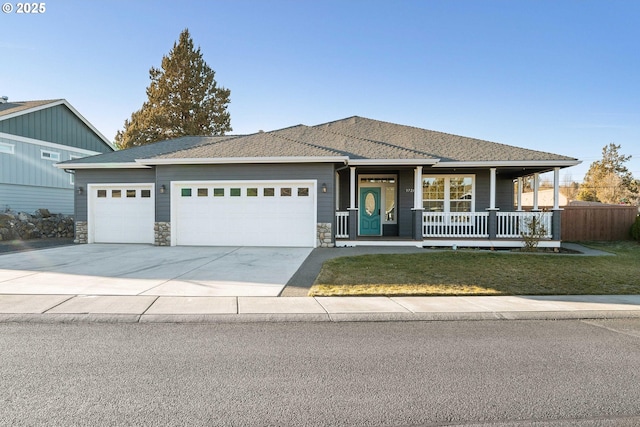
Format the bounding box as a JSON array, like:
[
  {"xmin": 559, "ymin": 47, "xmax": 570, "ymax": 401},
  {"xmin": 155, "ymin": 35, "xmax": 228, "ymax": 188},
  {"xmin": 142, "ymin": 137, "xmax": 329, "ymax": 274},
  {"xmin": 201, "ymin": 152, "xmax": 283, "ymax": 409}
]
[{"xmin": 335, "ymin": 165, "xmax": 561, "ymax": 248}]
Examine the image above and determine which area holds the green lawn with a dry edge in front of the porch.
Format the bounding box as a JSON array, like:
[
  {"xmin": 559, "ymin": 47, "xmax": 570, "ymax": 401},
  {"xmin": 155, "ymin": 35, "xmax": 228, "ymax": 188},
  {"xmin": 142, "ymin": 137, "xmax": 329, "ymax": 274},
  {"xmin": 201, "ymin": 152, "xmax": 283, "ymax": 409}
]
[{"xmin": 309, "ymin": 241, "xmax": 640, "ymax": 296}]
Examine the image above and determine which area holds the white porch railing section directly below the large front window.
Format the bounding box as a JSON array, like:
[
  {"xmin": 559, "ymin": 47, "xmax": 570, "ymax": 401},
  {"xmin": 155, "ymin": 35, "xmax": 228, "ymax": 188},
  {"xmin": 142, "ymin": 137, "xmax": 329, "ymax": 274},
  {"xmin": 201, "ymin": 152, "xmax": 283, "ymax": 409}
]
[{"xmin": 422, "ymin": 212, "xmax": 489, "ymax": 238}]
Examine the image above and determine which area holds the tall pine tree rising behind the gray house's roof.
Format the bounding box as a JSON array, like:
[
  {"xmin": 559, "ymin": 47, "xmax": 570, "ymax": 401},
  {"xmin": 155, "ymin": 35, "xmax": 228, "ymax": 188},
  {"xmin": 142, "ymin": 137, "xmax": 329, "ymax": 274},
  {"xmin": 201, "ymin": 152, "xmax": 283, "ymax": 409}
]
[{"xmin": 115, "ymin": 29, "xmax": 232, "ymax": 149}]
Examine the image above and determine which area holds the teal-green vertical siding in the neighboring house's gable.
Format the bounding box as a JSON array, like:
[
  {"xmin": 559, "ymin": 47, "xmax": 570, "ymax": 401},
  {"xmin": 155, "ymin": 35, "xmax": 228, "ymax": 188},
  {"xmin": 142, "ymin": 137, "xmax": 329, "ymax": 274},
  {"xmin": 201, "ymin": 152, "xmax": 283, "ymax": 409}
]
[{"xmin": 0, "ymin": 105, "xmax": 113, "ymax": 153}]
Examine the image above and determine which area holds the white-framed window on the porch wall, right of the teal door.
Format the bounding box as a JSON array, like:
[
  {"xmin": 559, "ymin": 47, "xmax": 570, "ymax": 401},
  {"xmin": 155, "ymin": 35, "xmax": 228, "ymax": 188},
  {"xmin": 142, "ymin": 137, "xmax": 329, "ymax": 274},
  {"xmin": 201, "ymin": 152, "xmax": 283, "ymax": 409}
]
[{"xmin": 422, "ymin": 175, "xmax": 475, "ymax": 212}]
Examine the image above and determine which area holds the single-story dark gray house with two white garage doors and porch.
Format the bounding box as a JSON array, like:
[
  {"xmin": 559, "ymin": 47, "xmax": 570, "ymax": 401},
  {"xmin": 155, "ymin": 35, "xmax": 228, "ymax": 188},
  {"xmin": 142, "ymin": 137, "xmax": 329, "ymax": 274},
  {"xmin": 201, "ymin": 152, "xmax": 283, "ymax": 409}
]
[{"xmin": 57, "ymin": 116, "xmax": 580, "ymax": 247}]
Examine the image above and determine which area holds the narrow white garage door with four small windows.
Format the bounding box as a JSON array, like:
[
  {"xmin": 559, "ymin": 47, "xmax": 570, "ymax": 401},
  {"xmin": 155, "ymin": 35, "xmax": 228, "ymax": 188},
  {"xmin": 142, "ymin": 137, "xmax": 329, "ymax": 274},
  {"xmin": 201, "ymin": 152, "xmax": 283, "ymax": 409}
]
[{"xmin": 87, "ymin": 184, "xmax": 155, "ymax": 243}]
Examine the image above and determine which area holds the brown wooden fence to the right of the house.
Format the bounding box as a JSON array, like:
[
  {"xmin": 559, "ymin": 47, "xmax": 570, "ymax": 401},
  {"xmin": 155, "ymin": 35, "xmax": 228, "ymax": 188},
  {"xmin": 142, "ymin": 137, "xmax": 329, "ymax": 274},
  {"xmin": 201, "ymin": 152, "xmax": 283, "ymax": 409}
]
[{"xmin": 561, "ymin": 205, "xmax": 638, "ymax": 242}]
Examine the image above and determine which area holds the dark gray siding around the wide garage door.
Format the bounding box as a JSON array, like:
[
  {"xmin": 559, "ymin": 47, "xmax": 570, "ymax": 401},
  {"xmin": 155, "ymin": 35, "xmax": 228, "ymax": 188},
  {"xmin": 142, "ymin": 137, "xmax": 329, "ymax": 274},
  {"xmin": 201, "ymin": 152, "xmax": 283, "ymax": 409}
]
[{"xmin": 156, "ymin": 163, "xmax": 335, "ymax": 224}]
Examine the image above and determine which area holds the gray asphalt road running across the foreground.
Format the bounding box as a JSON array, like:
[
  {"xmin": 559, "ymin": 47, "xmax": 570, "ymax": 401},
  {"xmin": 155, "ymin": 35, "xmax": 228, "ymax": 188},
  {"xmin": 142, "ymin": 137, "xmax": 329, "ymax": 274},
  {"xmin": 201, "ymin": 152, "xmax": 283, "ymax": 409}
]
[{"xmin": 0, "ymin": 320, "xmax": 640, "ymax": 426}]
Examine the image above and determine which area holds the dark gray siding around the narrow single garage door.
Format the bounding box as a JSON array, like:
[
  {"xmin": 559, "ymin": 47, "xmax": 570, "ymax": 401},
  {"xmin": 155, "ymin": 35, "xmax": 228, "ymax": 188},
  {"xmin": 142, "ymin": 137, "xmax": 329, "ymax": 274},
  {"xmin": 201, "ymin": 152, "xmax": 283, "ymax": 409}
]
[{"xmin": 75, "ymin": 169, "xmax": 159, "ymax": 221}]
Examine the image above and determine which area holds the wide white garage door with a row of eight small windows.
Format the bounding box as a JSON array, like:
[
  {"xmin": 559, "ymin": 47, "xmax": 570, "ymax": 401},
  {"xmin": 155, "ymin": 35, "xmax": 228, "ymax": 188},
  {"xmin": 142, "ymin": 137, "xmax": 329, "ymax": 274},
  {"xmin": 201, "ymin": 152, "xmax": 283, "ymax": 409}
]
[{"xmin": 171, "ymin": 181, "xmax": 316, "ymax": 247}]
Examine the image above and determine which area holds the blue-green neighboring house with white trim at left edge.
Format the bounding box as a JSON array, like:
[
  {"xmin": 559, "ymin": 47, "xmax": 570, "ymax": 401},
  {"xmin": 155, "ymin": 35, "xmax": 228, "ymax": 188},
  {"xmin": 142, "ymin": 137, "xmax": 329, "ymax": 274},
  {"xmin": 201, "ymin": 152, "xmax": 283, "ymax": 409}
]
[{"xmin": 0, "ymin": 97, "xmax": 113, "ymax": 214}]
